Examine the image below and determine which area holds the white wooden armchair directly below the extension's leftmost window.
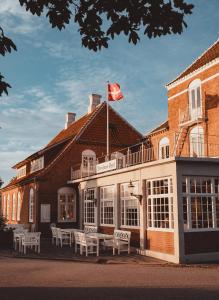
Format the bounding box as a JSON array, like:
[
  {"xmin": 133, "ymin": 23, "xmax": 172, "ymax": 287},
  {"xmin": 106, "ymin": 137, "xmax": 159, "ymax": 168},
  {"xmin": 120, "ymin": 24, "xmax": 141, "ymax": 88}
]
[{"xmin": 78, "ymin": 232, "xmax": 99, "ymax": 256}]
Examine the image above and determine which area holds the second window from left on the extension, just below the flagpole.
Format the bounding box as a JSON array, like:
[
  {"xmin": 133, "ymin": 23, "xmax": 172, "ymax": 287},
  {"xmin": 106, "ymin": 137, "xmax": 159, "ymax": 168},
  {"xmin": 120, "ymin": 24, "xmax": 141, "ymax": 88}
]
[{"xmin": 100, "ymin": 186, "xmax": 114, "ymax": 225}]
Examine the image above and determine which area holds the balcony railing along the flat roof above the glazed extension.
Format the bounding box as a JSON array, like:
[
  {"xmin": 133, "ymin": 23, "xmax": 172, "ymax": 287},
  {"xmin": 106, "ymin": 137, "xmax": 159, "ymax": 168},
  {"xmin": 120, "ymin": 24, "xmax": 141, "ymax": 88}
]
[{"xmin": 71, "ymin": 132, "xmax": 219, "ymax": 180}]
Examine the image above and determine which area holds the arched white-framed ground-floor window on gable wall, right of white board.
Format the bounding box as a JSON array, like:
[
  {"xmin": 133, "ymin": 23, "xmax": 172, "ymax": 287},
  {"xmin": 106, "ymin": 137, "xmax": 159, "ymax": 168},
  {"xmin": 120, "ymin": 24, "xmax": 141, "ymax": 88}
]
[{"xmin": 57, "ymin": 187, "xmax": 77, "ymax": 223}]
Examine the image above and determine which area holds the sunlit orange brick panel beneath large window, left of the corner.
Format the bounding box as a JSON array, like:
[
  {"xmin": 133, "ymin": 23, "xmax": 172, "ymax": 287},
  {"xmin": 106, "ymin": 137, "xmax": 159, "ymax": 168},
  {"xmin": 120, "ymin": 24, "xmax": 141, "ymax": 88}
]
[{"xmin": 145, "ymin": 230, "xmax": 174, "ymax": 254}]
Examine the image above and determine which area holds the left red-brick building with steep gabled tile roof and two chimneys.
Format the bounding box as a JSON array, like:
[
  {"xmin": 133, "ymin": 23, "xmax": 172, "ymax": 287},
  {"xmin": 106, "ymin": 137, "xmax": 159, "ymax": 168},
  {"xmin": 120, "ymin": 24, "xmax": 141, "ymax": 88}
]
[{"xmin": 1, "ymin": 94, "xmax": 143, "ymax": 233}]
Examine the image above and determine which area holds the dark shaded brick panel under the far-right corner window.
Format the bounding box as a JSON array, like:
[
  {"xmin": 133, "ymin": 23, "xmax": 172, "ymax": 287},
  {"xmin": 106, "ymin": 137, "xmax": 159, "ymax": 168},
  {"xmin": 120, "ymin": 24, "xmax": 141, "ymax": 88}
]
[{"xmin": 184, "ymin": 231, "xmax": 219, "ymax": 255}]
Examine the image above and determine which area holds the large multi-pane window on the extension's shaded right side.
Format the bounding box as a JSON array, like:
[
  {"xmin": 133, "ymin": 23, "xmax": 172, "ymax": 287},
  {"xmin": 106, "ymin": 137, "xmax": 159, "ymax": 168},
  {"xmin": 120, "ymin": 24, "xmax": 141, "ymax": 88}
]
[{"xmin": 182, "ymin": 177, "xmax": 219, "ymax": 230}]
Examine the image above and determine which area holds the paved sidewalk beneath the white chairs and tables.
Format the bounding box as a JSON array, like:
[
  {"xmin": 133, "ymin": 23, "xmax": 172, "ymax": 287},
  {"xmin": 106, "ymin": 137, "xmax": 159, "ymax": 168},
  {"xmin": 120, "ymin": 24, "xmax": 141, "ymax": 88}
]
[{"xmin": 0, "ymin": 238, "xmax": 169, "ymax": 266}]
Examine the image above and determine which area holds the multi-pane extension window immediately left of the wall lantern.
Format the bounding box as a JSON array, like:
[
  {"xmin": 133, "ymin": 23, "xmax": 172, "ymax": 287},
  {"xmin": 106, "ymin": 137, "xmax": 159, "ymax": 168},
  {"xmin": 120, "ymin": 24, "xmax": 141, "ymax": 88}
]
[{"xmin": 121, "ymin": 182, "xmax": 140, "ymax": 227}]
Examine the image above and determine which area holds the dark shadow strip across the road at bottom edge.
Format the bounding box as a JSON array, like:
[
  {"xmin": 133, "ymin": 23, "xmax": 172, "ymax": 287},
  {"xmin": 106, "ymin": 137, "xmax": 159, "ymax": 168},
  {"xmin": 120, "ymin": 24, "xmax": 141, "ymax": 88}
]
[{"xmin": 0, "ymin": 287, "xmax": 219, "ymax": 300}]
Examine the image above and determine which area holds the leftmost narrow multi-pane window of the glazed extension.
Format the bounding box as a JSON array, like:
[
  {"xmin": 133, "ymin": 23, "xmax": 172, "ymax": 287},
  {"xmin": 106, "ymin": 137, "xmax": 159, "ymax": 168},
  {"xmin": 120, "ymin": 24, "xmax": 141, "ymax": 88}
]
[{"xmin": 84, "ymin": 188, "xmax": 96, "ymax": 224}]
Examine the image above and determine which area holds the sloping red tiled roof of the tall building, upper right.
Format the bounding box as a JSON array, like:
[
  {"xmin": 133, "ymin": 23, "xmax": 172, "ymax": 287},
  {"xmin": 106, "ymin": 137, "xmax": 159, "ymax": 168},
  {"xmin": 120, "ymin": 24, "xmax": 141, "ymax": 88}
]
[{"xmin": 167, "ymin": 39, "xmax": 219, "ymax": 86}]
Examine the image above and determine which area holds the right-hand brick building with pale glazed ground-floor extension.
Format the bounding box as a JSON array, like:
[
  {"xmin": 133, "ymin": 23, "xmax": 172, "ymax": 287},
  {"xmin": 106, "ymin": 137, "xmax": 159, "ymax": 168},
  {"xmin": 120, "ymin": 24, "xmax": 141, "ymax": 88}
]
[{"xmin": 68, "ymin": 40, "xmax": 219, "ymax": 263}]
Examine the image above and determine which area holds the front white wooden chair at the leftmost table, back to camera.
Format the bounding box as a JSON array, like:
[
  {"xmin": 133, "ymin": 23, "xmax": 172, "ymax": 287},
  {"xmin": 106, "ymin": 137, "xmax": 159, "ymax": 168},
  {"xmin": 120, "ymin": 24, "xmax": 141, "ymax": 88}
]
[{"xmin": 21, "ymin": 232, "xmax": 41, "ymax": 254}]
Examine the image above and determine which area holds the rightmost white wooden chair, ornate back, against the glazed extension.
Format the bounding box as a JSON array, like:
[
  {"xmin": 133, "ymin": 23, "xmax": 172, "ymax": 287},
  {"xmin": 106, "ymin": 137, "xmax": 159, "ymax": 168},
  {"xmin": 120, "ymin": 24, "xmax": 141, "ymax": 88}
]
[{"xmin": 104, "ymin": 230, "xmax": 131, "ymax": 255}]
